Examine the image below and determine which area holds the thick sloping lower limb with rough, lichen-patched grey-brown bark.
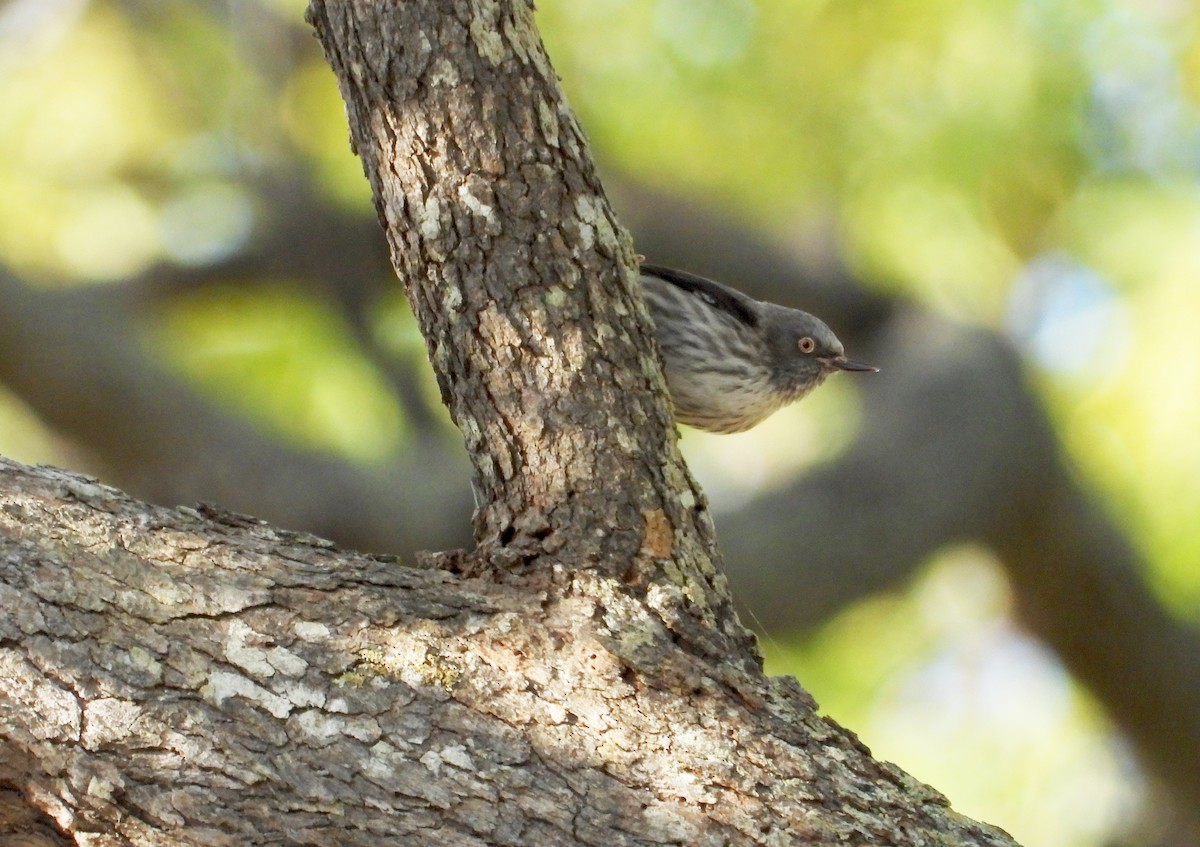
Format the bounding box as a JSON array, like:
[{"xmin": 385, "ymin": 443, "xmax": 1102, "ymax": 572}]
[{"xmin": 0, "ymin": 459, "xmax": 1013, "ymax": 847}]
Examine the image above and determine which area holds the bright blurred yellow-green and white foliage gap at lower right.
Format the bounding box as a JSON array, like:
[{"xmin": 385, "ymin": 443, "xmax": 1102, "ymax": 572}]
[{"xmin": 764, "ymin": 548, "xmax": 1141, "ymax": 847}]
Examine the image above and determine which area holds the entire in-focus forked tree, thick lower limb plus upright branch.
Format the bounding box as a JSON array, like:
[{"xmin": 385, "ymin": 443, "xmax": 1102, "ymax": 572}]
[{"xmin": 0, "ymin": 0, "xmax": 1012, "ymax": 847}]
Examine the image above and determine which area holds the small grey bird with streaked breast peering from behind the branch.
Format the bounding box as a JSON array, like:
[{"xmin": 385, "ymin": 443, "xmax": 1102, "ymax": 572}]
[{"xmin": 641, "ymin": 264, "xmax": 878, "ymax": 432}]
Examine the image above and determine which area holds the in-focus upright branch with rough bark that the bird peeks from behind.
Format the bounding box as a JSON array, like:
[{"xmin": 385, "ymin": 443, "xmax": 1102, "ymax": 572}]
[{"xmin": 308, "ymin": 0, "xmax": 757, "ymax": 665}]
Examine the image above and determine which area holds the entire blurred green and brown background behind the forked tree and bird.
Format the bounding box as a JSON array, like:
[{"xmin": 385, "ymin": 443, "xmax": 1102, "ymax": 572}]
[{"xmin": 0, "ymin": 0, "xmax": 1200, "ymax": 847}]
